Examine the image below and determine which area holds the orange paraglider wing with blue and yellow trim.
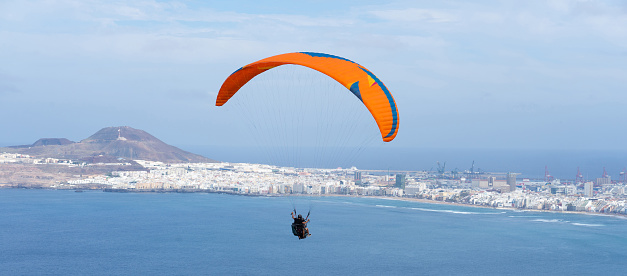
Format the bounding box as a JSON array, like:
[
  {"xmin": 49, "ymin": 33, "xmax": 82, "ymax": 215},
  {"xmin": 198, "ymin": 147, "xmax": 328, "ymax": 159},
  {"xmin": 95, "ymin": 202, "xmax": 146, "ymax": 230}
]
[{"xmin": 216, "ymin": 52, "xmax": 399, "ymax": 142}]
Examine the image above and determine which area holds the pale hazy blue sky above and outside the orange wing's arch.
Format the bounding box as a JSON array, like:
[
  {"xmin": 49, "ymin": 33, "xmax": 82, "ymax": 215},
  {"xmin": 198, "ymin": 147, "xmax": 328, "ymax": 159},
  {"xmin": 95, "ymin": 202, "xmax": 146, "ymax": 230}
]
[{"xmin": 0, "ymin": 0, "xmax": 627, "ymax": 150}]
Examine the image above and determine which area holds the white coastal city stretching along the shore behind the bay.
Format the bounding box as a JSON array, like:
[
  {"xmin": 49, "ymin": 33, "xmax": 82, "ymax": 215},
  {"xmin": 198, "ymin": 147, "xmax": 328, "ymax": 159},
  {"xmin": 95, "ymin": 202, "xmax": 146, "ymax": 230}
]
[{"xmin": 0, "ymin": 153, "xmax": 627, "ymax": 215}]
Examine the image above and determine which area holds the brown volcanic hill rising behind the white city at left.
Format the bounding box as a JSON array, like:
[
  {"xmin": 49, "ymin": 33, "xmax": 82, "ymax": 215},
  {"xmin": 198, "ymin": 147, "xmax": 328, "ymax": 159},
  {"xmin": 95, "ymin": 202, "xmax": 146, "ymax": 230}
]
[{"xmin": 0, "ymin": 126, "xmax": 218, "ymax": 163}]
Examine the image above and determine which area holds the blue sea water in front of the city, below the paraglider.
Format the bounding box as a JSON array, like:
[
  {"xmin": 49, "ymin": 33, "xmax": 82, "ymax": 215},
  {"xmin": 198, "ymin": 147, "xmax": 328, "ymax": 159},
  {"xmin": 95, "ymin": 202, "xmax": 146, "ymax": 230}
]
[{"xmin": 0, "ymin": 189, "xmax": 627, "ymax": 275}]
